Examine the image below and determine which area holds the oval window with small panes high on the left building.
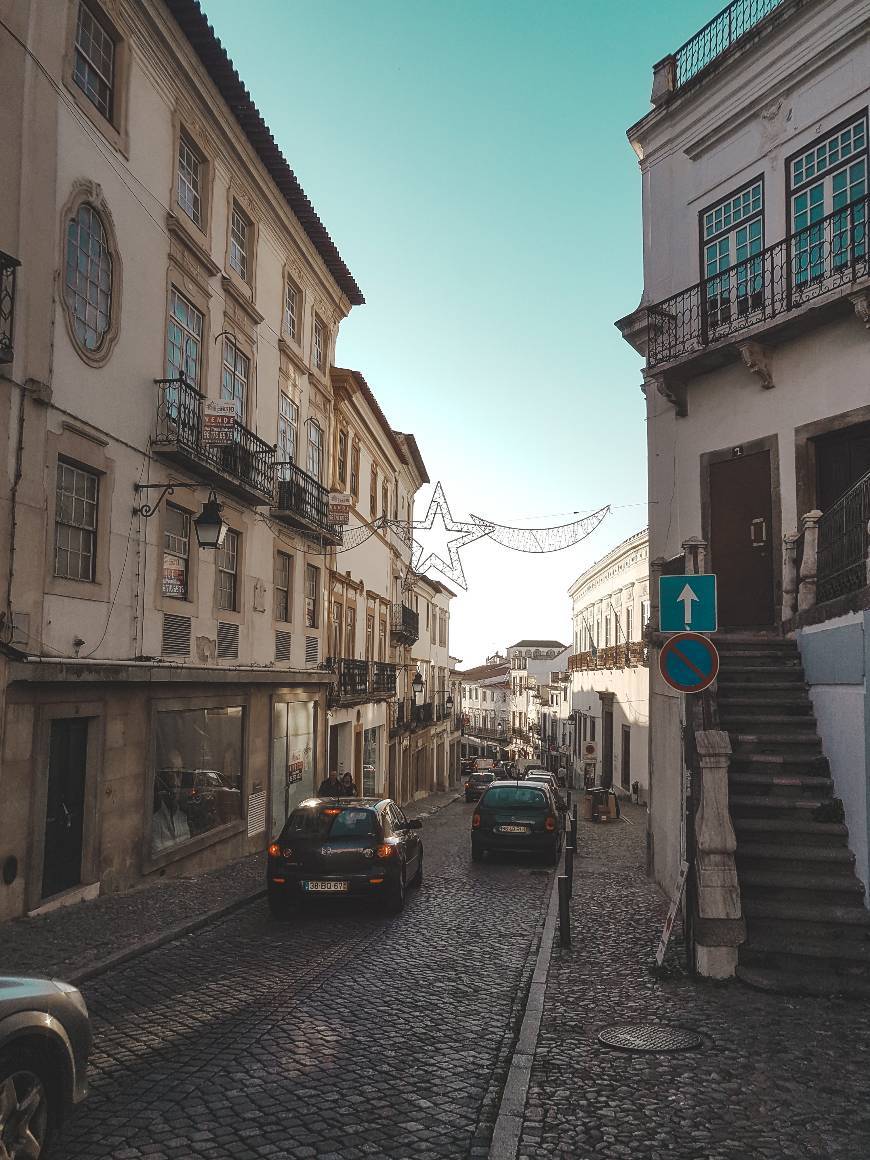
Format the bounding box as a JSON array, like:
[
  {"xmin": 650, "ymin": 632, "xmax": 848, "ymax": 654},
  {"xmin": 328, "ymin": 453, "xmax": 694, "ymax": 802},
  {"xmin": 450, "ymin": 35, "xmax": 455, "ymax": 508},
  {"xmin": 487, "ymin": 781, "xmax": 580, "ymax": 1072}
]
[{"xmin": 64, "ymin": 204, "xmax": 111, "ymax": 350}]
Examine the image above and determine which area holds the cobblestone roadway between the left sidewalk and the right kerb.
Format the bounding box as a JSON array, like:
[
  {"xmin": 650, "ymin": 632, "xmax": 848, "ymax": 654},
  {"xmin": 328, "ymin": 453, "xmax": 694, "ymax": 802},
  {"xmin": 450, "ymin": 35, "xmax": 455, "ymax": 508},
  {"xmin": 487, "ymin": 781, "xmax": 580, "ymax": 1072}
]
[{"xmin": 44, "ymin": 802, "xmax": 552, "ymax": 1160}]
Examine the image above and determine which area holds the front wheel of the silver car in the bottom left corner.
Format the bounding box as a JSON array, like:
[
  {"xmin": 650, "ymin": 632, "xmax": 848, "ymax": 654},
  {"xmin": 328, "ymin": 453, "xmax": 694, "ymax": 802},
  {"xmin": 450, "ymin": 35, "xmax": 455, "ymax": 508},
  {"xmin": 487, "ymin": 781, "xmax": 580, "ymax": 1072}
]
[{"xmin": 0, "ymin": 1046, "xmax": 56, "ymax": 1160}]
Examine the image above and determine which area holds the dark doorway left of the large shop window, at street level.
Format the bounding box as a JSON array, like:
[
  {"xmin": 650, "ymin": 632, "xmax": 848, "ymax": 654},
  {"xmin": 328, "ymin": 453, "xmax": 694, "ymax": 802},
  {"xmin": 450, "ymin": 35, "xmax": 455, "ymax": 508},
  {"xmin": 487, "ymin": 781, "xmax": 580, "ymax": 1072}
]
[{"xmin": 42, "ymin": 717, "xmax": 89, "ymax": 898}]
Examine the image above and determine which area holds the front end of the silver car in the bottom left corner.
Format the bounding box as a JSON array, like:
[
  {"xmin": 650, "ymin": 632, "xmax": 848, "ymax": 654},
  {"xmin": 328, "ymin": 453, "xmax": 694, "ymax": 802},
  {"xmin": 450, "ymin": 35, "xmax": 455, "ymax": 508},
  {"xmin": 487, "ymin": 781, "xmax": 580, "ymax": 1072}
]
[{"xmin": 0, "ymin": 976, "xmax": 92, "ymax": 1160}]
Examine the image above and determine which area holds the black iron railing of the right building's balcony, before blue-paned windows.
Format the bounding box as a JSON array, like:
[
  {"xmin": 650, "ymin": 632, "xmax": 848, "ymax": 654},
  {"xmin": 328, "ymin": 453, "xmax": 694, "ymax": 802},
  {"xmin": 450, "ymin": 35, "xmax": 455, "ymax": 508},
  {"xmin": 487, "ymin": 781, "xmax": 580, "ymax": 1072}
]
[{"xmin": 647, "ymin": 196, "xmax": 870, "ymax": 368}]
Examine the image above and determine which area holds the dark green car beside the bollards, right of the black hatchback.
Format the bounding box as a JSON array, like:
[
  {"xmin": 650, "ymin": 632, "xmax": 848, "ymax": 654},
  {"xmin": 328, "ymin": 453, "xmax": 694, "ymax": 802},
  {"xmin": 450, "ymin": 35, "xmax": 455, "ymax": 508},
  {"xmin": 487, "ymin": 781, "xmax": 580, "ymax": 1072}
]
[{"xmin": 471, "ymin": 781, "xmax": 565, "ymax": 864}]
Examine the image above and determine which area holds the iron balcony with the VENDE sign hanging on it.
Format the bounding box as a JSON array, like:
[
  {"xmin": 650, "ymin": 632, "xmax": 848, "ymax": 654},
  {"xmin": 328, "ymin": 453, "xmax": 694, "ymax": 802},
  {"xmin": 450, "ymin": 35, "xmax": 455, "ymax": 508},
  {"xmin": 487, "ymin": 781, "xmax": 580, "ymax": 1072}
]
[{"xmin": 154, "ymin": 378, "xmax": 275, "ymax": 505}]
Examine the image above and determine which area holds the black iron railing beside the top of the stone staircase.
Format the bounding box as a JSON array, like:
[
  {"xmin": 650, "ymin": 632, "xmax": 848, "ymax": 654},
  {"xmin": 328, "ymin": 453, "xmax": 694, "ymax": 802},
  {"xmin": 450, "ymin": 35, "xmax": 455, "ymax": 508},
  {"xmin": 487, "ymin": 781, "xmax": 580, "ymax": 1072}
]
[{"xmin": 815, "ymin": 472, "xmax": 870, "ymax": 604}]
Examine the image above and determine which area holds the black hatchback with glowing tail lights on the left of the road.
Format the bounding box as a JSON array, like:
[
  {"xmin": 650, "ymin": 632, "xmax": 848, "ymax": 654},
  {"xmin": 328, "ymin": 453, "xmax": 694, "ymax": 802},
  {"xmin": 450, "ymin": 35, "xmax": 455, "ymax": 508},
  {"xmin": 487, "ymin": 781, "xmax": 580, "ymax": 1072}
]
[{"xmin": 266, "ymin": 798, "xmax": 423, "ymax": 916}]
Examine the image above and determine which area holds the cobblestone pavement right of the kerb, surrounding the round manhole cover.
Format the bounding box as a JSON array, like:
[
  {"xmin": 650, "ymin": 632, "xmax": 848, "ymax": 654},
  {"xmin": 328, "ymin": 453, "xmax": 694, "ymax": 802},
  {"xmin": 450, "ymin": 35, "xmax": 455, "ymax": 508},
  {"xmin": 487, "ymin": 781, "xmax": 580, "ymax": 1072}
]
[{"xmin": 519, "ymin": 806, "xmax": 870, "ymax": 1160}]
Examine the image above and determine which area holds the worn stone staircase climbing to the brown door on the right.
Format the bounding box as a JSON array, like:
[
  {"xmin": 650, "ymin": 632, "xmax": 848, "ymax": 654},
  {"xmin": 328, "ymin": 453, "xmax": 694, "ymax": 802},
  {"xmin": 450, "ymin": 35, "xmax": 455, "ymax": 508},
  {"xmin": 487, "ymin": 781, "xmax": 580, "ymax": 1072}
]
[{"xmin": 716, "ymin": 635, "xmax": 870, "ymax": 998}]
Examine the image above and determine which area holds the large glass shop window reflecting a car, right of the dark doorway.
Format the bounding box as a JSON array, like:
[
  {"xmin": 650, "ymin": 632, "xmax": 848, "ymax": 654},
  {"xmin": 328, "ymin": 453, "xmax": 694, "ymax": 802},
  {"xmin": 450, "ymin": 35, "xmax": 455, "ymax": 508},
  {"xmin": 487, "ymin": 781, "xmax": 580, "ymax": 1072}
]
[{"xmin": 151, "ymin": 706, "xmax": 245, "ymax": 855}]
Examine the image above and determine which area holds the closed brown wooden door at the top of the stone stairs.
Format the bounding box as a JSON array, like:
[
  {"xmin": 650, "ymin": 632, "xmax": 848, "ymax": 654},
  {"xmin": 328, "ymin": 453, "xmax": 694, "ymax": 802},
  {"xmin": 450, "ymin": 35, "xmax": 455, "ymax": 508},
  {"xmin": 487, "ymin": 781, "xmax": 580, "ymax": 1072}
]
[{"xmin": 710, "ymin": 451, "xmax": 774, "ymax": 629}]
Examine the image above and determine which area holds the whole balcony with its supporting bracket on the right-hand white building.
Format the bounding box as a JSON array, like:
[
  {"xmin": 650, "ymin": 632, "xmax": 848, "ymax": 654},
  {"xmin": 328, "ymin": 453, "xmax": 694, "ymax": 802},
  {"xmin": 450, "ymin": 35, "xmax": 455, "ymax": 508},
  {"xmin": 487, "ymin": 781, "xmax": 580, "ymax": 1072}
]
[{"xmin": 646, "ymin": 196, "xmax": 870, "ymax": 386}]
